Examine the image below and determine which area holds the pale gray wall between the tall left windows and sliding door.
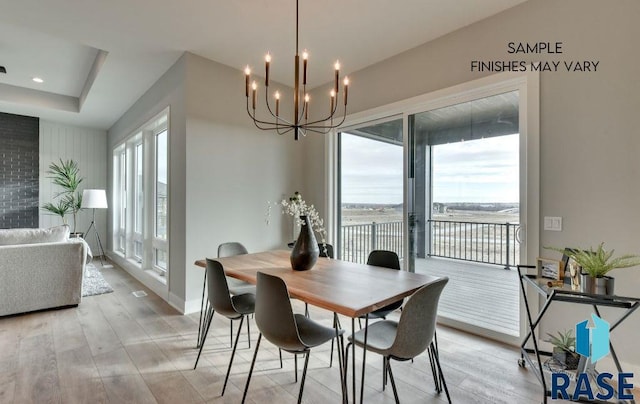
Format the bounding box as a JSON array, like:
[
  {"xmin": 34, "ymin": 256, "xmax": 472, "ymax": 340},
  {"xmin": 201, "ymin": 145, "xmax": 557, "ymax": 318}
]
[{"xmin": 180, "ymin": 54, "xmax": 304, "ymax": 310}]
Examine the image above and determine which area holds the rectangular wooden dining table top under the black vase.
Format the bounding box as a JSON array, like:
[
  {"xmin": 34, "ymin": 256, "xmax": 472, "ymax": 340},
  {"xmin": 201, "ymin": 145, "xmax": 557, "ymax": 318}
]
[{"xmin": 195, "ymin": 250, "xmax": 439, "ymax": 317}]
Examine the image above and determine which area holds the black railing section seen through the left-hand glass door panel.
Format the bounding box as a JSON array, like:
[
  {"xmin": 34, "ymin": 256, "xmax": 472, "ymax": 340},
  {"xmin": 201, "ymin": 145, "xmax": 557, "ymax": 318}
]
[{"xmin": 339, "ymin": 221, "xmax": 403, "ymax": 264}]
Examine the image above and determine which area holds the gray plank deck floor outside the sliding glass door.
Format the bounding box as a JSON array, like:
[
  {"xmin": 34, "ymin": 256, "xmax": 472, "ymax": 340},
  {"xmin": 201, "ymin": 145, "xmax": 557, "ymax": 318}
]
[{"xmin": 416, "ymin": 258, "xmax": 520, "ymax": 337}]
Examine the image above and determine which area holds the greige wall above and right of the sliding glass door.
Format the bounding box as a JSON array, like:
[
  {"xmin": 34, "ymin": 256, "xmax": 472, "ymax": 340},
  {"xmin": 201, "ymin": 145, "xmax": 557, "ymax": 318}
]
[{"xmin": 305, "ymin": 0, "xmax": 640, "ymax": 366}]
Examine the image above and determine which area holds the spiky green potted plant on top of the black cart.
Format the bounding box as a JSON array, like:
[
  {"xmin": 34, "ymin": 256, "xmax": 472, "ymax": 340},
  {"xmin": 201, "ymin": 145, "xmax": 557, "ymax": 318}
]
[{"xmin": 545, "ymin": 243, "xmax": 640, "ymax": 295}]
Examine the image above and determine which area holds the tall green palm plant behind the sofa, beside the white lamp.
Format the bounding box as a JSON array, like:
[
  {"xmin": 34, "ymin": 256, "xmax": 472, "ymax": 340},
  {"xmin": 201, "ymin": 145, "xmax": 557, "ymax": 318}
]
[{"xmin": 42, "ymin": 159, "xmax": 84, "ymax": 236}]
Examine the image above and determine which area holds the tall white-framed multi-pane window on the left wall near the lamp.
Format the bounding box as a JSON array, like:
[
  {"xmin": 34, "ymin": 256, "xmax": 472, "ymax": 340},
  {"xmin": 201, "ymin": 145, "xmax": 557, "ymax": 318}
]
[{"xmin": 113, "ymin": 110, "xmax": 169, "ymax": 279}]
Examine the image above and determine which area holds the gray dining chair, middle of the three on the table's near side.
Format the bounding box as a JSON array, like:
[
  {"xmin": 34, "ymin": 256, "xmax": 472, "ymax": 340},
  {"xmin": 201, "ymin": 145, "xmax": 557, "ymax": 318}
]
[{"xmin": 242, "ymin": 272, "xmax": 346, "ymax": 403}]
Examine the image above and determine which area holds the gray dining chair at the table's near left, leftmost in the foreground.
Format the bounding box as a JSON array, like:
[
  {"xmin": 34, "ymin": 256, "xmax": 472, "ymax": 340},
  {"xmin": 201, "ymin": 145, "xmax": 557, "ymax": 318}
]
[{"xmin": 193, "ymin": 258, "xmax": 256, "ymax": 396}]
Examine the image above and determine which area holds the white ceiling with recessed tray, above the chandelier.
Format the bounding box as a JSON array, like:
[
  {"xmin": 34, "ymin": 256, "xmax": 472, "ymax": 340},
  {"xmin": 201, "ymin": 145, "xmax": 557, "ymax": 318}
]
[{"xmin": 0, "ymin": 0, "xmax": 525, "ymax": 129}]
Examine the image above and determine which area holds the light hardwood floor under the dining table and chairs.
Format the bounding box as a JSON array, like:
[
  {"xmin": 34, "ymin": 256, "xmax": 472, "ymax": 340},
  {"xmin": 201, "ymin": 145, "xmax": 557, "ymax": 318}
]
[{"xmin": 0, "ymin": 260, "xmax": 541, "ymax": 404}]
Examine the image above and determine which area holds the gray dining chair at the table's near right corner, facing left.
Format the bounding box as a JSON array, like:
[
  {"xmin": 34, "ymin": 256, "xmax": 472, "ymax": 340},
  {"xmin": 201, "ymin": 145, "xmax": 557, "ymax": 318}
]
[{"xmin": 345, "ymin": 277, "xmax": 451, "ymax": 403}]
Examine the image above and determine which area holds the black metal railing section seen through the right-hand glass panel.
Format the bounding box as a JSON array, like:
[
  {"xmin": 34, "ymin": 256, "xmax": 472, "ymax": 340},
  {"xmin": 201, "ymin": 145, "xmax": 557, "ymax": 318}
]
[{"xmin": 427, "ymin": 220, "xmax": 520, "ymax": 269}]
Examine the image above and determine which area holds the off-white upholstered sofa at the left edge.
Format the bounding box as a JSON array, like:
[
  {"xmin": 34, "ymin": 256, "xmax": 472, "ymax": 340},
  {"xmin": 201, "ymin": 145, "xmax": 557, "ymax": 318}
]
[{"xmin": 0, "ymin": 226, "xmax": 88, "ymax": 316}]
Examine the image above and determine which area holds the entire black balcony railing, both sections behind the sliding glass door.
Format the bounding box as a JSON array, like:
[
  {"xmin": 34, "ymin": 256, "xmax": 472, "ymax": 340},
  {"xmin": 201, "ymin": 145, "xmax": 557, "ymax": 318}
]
[{"xmin": 339, "ymin": 220, "xmax": 520, "ymax": 268}]
